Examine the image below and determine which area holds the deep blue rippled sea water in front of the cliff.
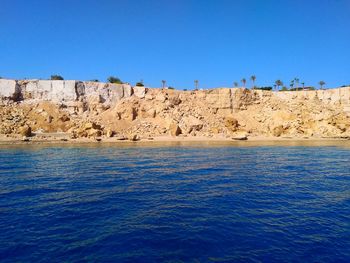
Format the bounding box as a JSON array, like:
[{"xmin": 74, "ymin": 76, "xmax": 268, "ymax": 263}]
[{"xmin": 0, "ymin": 143, "xmax": 350, "ymax": 262}]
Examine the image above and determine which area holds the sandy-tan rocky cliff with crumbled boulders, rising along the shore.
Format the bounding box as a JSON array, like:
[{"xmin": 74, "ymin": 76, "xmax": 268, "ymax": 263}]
[{"xmin": 0, "ymin": 79, "xmax": 350, "ymax": 138}]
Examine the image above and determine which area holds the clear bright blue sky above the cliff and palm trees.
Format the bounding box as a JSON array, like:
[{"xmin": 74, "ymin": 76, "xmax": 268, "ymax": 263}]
[{"xmin": 0, "ymin": 0, "xmax": 350, "ymax": 88}]
